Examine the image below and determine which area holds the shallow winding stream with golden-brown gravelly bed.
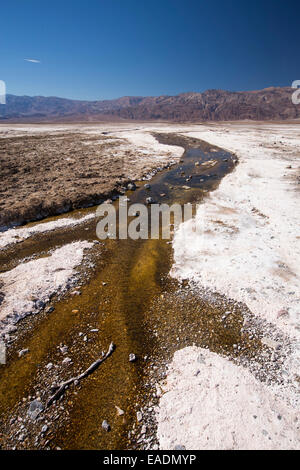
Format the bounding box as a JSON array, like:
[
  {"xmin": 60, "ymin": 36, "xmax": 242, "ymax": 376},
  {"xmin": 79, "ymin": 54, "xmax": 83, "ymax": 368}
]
[{"xmin": 0, "ymin": 134, "xmax": 251, "ymax": 449}]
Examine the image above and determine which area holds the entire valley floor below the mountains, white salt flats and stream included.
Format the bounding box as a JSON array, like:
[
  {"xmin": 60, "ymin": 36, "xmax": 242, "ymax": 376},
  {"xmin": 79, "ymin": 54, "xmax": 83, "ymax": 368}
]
[{"xmin": 0, "ymin": 121, "xmax": 300, "ymax": 449}]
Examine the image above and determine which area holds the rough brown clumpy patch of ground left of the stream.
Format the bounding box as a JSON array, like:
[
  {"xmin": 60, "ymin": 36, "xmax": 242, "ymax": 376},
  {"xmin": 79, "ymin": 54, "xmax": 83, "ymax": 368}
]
[{"xmin": 0, "ymin": 132, "xmax": 166, "ymax": 227}]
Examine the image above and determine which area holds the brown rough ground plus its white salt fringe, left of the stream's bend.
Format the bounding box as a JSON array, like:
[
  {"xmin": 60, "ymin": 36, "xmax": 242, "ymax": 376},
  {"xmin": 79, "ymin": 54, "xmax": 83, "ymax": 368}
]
[{"xmin": 0, "ymin": 125, "xmax": 183, "ymax": 229}]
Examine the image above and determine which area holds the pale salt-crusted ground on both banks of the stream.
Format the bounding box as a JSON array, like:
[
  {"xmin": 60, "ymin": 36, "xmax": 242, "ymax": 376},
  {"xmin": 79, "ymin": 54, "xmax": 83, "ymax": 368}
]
[{"xmin": 0, "ymin": 122, "xmax": 300, "ymax": 449}]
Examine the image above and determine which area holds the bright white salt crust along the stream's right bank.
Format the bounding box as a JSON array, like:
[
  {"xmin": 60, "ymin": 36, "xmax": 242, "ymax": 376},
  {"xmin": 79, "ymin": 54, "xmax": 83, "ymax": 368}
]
[{"xmin": 158, "ymin": 123, "xmax": 300, "ymax": 449}]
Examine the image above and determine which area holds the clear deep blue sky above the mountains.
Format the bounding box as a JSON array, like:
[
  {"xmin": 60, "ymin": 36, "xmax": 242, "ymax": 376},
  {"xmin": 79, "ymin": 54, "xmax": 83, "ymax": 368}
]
[{"xmin": 0, "ymin": 0, "xmax": 300, "ymax": 100}]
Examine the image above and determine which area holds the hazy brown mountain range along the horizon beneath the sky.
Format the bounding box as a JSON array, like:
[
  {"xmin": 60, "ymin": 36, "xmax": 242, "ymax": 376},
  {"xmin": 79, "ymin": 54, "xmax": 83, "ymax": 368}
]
[{"xmin": 0, "ymin": 87, "xmax": 300, "ymax": 122}]
